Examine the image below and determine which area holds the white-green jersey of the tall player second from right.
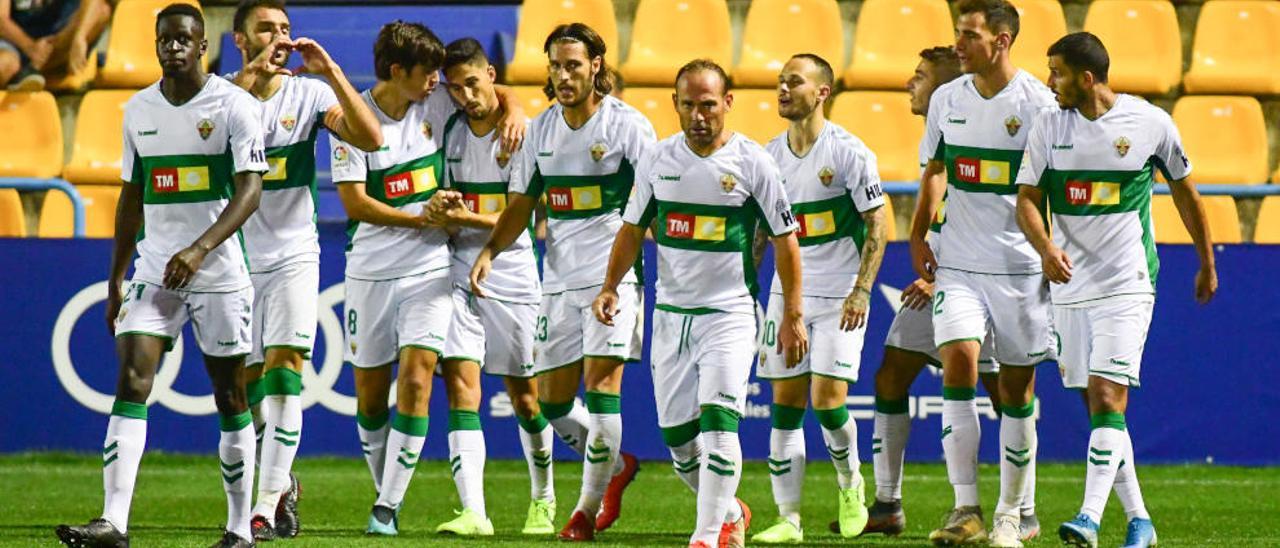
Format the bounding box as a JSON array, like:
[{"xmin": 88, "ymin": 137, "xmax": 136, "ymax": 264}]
[{"xmin": 924, "ymin": 70, "xmax": 1057, "ymax": 274}]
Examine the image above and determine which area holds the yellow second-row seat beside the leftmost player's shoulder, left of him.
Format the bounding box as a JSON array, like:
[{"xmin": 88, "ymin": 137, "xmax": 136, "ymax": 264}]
[{"xmin": 63, "ymin": 90, "xmax": 134, "ymax": 184}]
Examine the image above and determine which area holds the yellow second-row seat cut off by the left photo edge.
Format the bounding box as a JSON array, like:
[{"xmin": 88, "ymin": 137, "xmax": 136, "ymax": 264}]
[{"xmin": 0, "ymin": 91, "xmax": 62, "ymax": 179}]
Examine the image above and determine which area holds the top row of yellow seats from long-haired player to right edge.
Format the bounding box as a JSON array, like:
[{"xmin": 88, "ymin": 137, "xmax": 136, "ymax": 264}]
[{"xmin": 507, "ymin": 0, "xmax": 1280, "ymax": 95}]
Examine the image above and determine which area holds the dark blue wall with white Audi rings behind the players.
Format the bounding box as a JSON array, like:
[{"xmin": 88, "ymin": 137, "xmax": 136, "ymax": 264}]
[{"xmin": 0, "ymin": 229, "xmax": 1280, "ymax": 465}]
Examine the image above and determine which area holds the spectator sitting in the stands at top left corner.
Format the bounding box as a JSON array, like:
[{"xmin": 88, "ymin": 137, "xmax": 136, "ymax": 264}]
[{"xmin": 0, "ymin": 0, "xmax": 116, "ymax": 91}]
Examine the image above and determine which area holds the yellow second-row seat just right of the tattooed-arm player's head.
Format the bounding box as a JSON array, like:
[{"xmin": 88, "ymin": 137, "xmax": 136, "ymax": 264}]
[{"xmin": 831, "ymin": 91, "xmax": 924, "ymax": 182}]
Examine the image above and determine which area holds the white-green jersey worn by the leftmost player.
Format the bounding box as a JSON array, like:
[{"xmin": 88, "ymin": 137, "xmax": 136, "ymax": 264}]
[{"xmin": 120, "ymin": 77, "xmax": 268, "ymax": 293}]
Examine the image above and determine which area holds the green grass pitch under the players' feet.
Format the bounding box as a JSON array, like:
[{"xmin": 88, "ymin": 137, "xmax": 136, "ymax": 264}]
[{"xmin": 0, "ymin": 453, "xmax": 1280, "ymax": 548}]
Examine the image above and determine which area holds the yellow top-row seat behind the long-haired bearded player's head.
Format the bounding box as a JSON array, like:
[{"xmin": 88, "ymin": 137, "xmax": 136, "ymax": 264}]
[{"xmin": 507, "ymin": 0, "xmax": 618, "ymax": 83}]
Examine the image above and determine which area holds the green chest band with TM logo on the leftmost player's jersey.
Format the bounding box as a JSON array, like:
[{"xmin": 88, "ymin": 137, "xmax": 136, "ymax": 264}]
[{"xmin": 133, "ymin": 151, "xmax": 236, "ymax": 205}]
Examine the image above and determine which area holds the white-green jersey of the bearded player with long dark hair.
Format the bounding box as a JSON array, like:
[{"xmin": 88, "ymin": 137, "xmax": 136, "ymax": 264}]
[{"xmin": 511, "ymin": 96, "xmax": 655, "ymax": 293}]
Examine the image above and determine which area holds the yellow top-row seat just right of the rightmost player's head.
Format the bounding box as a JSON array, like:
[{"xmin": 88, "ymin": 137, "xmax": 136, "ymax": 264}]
[{"xmin": 1084, "ymin": 0, "xmax": 1183, "ymax": 95}]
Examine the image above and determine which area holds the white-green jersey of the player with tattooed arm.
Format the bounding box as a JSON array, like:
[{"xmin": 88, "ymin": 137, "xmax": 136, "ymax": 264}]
[{"xmin": 765, "ymin": 122, "xmax": 884, "ymax": 298}]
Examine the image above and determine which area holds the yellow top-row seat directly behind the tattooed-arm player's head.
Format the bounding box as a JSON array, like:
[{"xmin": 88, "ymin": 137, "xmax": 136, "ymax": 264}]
[{"xmin": 733, "ymin": 0, "xmax": 845, "ymax": 87}]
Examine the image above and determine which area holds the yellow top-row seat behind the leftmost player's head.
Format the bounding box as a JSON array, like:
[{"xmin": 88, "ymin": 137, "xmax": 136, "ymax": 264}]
[{"xmin": 97, "ymin": 0, "xmax": 199, "ymax": 88}]
